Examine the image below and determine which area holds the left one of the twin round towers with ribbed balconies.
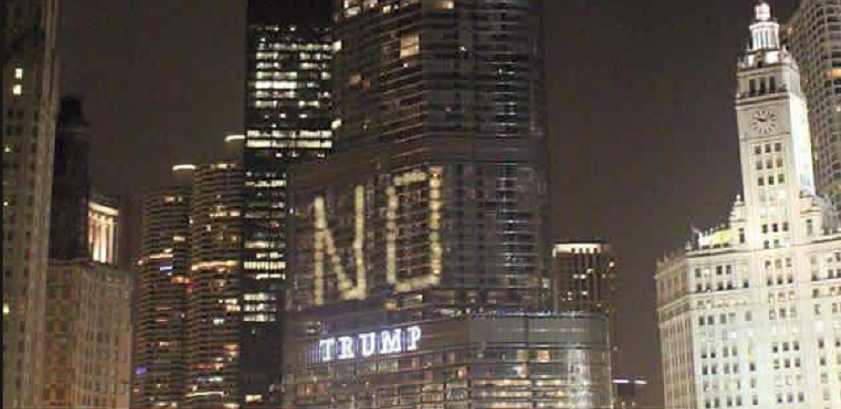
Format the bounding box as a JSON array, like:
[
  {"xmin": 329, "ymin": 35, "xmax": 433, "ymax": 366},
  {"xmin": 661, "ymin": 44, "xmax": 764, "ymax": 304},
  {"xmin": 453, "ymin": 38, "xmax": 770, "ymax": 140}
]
[{"xmin": 132, "ymin": 165, "xmax": 195, "ymax": 409}]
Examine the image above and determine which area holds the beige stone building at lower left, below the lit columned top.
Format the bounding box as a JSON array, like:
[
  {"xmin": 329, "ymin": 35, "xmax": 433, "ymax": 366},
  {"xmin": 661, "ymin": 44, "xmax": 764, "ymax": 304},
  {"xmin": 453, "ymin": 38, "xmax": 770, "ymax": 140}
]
[{"xmin": 37, "ymin": 258, "xmax": 134, "ymax": 409}]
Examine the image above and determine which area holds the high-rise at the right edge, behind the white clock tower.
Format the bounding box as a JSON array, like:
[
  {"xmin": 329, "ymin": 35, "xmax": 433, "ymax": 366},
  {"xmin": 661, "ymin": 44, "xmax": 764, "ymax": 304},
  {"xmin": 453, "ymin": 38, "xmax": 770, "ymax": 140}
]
[{"xmin": 785, "ymin": 0, "xmax": 841, "ymax": 210}]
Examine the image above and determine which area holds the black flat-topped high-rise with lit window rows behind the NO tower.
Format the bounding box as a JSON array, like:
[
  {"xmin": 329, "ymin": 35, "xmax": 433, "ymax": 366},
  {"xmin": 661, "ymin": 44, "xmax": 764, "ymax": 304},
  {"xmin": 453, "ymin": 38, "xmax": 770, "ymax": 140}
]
[{"xmin": 240, "ymin": 0, "xmax": 332, "ymax": 407}]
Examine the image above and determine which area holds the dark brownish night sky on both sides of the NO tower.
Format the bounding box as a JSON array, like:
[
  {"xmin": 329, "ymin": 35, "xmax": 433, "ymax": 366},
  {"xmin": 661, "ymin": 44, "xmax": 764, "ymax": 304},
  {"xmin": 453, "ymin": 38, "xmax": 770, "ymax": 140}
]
[{"xmin": 59, "ymin": 0, "xmax": 796, "ymax": 404}]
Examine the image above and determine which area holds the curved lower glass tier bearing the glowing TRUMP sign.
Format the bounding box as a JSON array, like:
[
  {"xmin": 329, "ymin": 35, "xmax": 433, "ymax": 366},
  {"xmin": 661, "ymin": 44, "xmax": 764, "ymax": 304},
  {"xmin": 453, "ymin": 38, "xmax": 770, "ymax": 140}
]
[{"xmin": 285, "ymin": 315, "xmax": 611, "ymax": 409}]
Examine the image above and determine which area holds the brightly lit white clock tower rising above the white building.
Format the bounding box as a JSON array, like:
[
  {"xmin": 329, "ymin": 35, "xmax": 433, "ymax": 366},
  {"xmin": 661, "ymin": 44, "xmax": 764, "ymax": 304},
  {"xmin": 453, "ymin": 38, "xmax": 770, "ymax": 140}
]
[{"xmin": 731, "ymin": 1, "xmax": 815, "ymax": 248}]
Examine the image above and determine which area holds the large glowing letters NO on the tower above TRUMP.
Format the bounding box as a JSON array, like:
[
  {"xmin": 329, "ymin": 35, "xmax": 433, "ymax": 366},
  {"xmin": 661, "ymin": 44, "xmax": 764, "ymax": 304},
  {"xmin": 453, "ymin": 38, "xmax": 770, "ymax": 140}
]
[{"xmin": 313, "ymin": 167, "xmax": 442, "ymax": 305}]
